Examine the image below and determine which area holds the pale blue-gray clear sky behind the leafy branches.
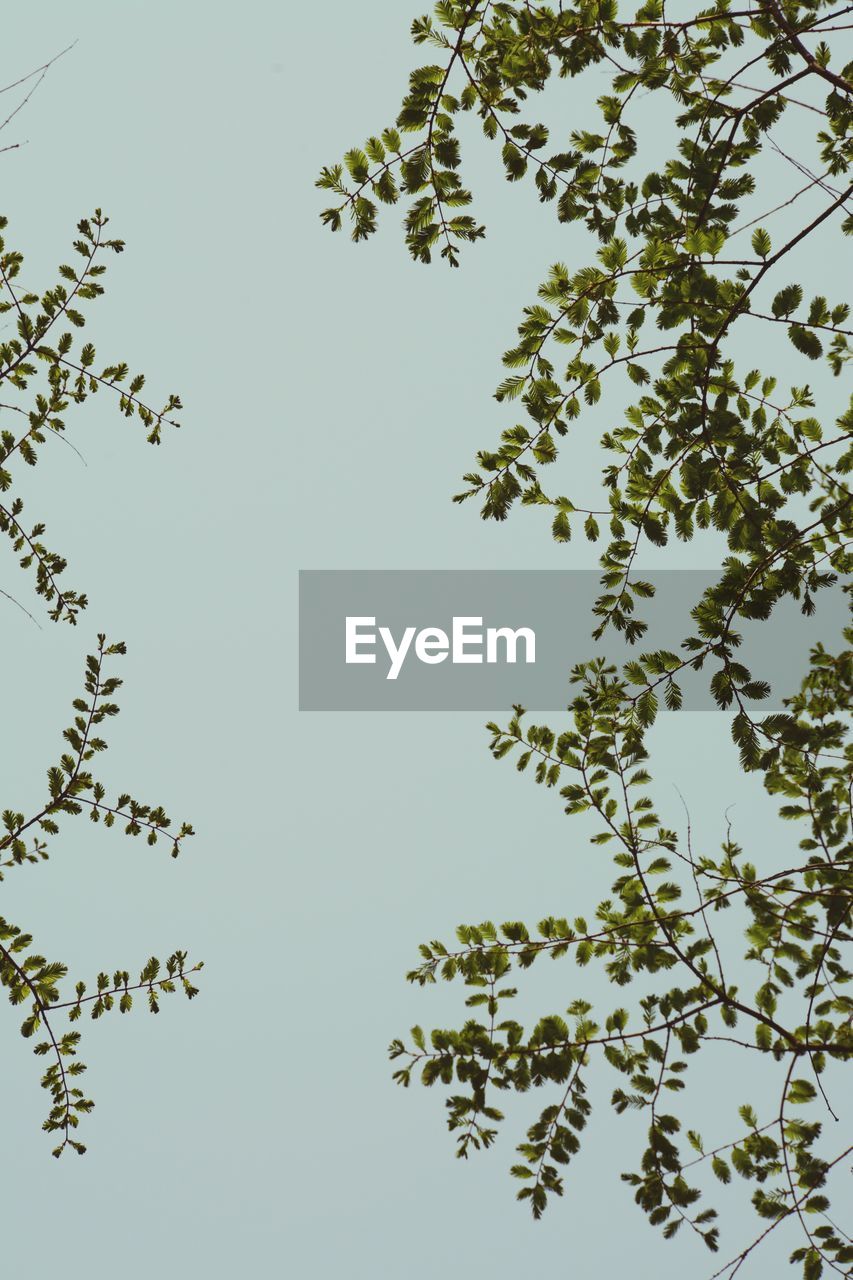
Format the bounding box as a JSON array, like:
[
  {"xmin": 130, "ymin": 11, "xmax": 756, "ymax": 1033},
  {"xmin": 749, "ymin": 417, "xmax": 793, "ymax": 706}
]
[{"xmin": 0, "ymin": 0, "xmax": 845, "ymax": 1280}]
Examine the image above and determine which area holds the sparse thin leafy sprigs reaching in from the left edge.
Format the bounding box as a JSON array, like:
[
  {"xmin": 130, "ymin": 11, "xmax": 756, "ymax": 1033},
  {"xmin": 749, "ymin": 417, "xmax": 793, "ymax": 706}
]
[{"xmin": 0, "ymin": 209, "xmax": 201, "ymax": 1156}]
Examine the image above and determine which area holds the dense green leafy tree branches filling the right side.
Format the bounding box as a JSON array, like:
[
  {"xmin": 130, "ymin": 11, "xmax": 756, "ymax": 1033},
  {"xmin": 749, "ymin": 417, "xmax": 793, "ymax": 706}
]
[{"xmin": 318, "ymin": 0, "xmax": 853, "ymax": 1280}]
